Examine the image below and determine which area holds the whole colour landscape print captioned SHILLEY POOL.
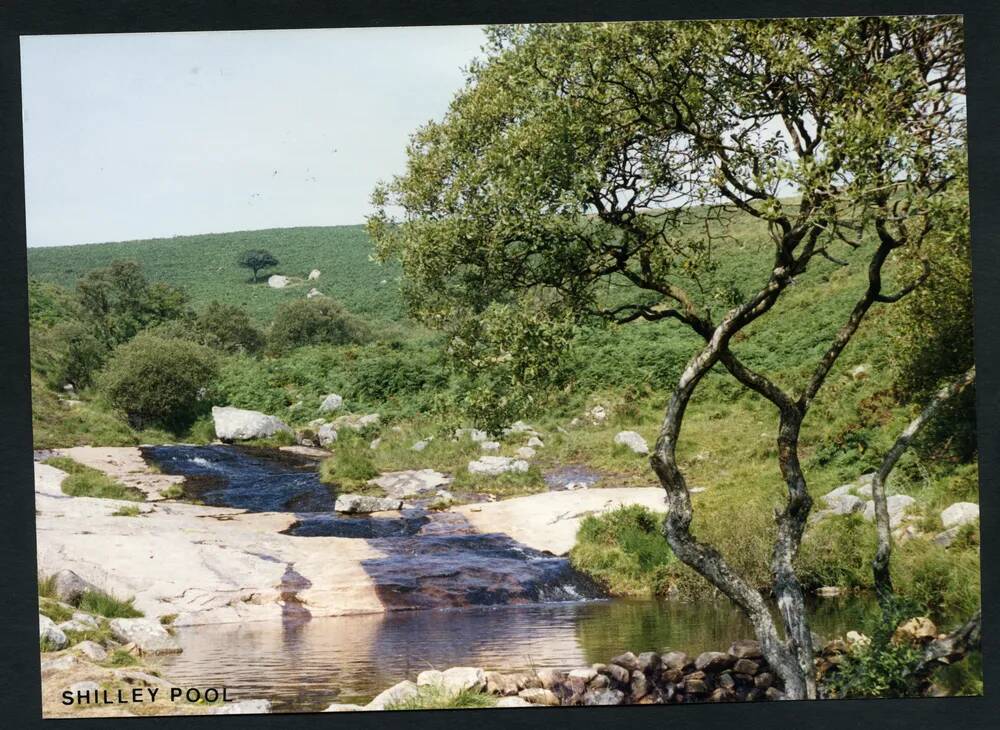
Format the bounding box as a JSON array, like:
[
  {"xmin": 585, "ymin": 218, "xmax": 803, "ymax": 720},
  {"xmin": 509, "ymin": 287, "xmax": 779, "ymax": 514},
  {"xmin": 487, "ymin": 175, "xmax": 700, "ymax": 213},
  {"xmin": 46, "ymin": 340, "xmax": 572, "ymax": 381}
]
[{"xmin": 18, "ymin": 15, "xmax": 992, "ymax": 722}]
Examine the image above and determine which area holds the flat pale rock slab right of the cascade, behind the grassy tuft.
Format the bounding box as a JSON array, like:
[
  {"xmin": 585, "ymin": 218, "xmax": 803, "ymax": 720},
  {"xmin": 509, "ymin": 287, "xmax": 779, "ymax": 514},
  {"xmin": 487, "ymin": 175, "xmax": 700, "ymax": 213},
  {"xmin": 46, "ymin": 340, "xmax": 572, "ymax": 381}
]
[{"xmin": 451, "ymin": 487, "xmax": 667, "ymax": 555}]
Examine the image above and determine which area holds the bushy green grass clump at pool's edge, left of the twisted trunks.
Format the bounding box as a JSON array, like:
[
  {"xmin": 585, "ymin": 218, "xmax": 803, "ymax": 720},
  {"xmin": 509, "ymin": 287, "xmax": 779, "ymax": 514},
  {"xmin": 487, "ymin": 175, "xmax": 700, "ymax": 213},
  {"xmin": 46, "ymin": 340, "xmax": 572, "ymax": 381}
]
[{"xmin": 570, "ymin": 505, "xmax": 675, "ymax": 596}]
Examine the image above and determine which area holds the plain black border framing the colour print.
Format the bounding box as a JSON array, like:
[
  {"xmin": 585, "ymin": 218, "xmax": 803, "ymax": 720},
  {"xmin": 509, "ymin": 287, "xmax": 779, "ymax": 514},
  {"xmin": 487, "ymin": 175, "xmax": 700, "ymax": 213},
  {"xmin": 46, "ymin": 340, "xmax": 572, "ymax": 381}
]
[{"xmin": 0, "ymin": 0, "xmax": 1000, "ymax": 730}]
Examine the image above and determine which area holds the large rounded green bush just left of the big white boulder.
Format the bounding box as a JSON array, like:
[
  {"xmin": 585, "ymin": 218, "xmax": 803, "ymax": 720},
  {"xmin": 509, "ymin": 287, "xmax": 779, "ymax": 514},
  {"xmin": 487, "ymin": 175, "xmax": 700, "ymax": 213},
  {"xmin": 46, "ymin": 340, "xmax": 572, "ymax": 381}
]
[{"xmin": 101, "ymin": 334, "xmax": 218, "ymax": 431}]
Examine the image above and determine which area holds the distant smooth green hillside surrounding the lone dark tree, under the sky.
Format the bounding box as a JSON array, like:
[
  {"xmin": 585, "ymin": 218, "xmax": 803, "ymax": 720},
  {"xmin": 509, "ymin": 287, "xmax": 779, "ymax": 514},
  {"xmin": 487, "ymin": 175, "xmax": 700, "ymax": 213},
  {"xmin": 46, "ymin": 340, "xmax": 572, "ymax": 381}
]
[{"xmin": 28, "ymin": 225, "xmax": 402, "ymax": 323}]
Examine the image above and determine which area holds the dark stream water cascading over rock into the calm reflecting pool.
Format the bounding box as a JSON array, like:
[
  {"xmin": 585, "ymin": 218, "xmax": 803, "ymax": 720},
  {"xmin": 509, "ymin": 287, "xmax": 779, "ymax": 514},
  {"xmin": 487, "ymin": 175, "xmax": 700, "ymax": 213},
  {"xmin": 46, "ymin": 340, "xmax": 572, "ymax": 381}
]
[{"xmin": 144, "ymin": 446, "xmax": 884, "ymax": 712}]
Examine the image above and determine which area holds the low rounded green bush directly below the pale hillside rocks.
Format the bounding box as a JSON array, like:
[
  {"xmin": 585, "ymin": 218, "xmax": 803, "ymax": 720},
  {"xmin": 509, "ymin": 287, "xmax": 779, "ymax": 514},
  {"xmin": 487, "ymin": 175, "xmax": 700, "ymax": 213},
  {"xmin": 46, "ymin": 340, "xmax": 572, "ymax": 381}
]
[{"xmin": 268, "ymin": 297, "xmax": 369, "ymax": 352}]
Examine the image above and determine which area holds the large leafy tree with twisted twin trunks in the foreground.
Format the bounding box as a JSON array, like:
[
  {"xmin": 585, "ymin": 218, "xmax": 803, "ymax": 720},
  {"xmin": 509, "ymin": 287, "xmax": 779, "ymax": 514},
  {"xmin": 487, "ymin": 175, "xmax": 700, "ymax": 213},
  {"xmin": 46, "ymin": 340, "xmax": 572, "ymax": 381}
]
[{"xmin": 369, "ymin": 17, "xmax": 965, "ymax": 698}]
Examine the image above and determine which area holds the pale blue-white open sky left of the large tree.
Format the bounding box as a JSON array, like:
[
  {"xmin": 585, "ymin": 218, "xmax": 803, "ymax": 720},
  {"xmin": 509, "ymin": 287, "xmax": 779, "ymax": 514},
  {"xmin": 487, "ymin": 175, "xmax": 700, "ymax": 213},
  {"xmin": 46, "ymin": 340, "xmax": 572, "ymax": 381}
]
[{"xmin": 21, "ymin": 26, "xmax": 484, "ymax": 246}]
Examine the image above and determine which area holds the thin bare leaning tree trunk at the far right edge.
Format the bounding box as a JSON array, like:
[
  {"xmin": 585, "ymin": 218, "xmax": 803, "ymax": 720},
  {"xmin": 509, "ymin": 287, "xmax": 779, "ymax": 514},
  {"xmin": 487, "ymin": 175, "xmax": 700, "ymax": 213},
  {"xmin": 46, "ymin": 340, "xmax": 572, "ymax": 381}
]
[{"xmin": 872, "ymin": 365, "xmax": 976, "ymax": 606}]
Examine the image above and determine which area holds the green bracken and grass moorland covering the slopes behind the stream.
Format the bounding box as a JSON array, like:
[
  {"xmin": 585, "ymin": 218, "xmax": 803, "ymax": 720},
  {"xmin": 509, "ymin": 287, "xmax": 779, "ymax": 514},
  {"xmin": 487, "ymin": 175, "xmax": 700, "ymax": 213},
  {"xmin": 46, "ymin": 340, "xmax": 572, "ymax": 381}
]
[{"xmin": 29, "ymin": 213, "xmax": 979, "ymax": 615}]
